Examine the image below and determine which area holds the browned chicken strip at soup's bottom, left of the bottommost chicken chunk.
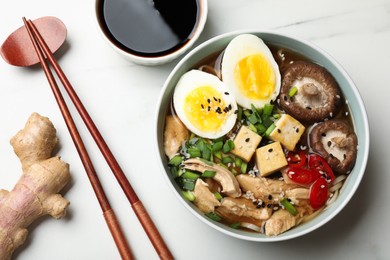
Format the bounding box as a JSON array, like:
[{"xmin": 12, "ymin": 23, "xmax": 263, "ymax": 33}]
[{"xmin": 221, "ymin": 197, "xmax": 272, "ymax": 220}]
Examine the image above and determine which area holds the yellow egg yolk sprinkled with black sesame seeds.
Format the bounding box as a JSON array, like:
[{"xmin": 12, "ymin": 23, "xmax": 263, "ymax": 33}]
[{"xmin": 183, "ymin": 86, "xmax": 227, "ymax": 132}]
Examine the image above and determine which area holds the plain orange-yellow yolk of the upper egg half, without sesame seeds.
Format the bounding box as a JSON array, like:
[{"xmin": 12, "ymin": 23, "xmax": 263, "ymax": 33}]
[{"xmin": 234, "ymin": 54, "xmax": 276, "ymax": 100}]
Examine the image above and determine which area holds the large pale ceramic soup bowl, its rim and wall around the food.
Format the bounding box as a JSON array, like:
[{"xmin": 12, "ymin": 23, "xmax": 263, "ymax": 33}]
[{"xmin": 154, "ymin": 31, "xmax": 370, "ymax": 242}]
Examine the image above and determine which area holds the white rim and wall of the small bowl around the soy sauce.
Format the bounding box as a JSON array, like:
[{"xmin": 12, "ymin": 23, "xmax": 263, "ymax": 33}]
[{"xmin": 95, "ymin": 0, "xmax": 208, "ymax": 66}]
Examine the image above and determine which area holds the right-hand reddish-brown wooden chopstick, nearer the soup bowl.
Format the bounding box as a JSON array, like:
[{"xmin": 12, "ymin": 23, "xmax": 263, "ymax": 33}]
[{"xmin": 22, "ymin": 17, "xmax": 173, "ymax": 259}]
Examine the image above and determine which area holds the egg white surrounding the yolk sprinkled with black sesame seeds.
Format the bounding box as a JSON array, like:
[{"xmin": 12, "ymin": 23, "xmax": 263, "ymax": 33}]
[{"xmin": 173, "ymin": 70, "xmax": 237, "ymax": 139}]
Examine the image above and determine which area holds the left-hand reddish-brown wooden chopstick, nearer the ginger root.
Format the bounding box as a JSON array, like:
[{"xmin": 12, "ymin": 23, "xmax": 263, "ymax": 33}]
[{"xmin": 23, "ymin": 17, "xmax": 134, "ymax": 259}]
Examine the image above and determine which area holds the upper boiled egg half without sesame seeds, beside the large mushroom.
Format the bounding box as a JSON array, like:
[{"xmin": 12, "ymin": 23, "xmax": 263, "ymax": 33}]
[{"xmin": 222, "ymin": 34, "xmax": 280, "ymax": 109}]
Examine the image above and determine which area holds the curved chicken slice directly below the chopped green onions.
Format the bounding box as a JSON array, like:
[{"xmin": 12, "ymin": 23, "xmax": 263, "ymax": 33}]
[{"xmin": 183, "ymin": 158, "xmax": 241, "ymax": 198}]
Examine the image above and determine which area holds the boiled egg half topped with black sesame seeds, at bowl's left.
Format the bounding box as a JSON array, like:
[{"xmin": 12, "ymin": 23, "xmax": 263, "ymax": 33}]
[{"xmin": 173, "ymin": 70, "xmax": 237, "ymax": 139}]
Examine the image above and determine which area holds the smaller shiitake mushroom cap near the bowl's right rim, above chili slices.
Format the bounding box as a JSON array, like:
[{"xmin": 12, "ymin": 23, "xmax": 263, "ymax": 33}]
[{"xmin": 309, "ymin": 119, "xmax": 358, "ymax": 174}]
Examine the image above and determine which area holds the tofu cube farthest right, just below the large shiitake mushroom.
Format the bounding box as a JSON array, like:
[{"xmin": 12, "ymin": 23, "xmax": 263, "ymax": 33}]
[{"xmin": 269, "ymin": 114, "xmax": 305, "ymax": 151}]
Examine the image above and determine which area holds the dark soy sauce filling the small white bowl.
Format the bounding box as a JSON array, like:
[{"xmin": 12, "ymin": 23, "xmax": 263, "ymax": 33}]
[{"xmin": 97, "ymin": 0, "xmax": 200, "ymax": 57}]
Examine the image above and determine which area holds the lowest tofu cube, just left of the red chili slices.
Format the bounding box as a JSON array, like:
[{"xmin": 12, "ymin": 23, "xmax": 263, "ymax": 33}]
[{"xmin": 256, "ymin": 142, "xmax": 287, "ymax": 177}]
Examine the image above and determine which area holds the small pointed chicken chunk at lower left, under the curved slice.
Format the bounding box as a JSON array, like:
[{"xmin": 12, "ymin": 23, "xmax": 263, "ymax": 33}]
[{"xmin": 193, "ymin": 178, "xmax": 221, "ymax": 213}]
